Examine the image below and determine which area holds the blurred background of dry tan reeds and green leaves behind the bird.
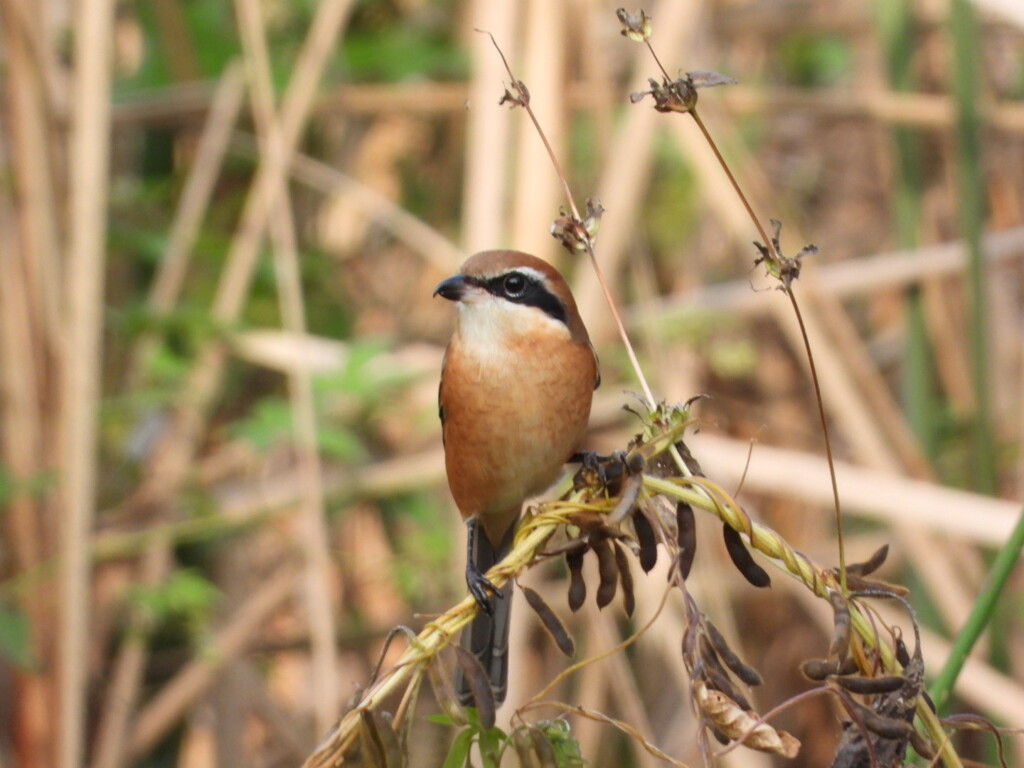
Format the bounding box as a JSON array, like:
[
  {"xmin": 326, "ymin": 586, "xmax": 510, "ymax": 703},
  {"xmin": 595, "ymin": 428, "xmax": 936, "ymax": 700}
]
[{"xmin": 0, "ymin": 0, "xmax": 1024, "ymax": 768}]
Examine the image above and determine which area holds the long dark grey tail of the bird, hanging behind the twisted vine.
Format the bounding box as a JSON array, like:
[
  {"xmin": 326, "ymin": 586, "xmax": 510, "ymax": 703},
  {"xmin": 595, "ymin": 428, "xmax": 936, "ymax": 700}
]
[{"xmin": 456, "ymin": 524, "xmax": 516, "ymax": 707}]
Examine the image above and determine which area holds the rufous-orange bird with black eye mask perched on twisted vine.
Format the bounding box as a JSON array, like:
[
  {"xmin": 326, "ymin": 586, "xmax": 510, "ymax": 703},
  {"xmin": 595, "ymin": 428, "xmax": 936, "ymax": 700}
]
[{"xmin": 434, "ymin": 250, "xmax": 601, "ymax": 706}]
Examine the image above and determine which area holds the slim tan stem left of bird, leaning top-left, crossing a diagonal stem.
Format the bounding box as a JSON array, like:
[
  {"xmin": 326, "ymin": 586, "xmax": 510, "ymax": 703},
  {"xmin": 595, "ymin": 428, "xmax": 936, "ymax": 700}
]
[{"xmin": 236, "ymin": 0, "xmax": 338, "ymax": 733}]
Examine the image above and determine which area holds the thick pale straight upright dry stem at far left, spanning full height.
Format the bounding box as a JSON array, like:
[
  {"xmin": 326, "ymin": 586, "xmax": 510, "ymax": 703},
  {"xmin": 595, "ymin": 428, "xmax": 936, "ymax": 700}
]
[{"xmin": 57, "ymin": 0, "xmax": 114, "ymax": 768}]
